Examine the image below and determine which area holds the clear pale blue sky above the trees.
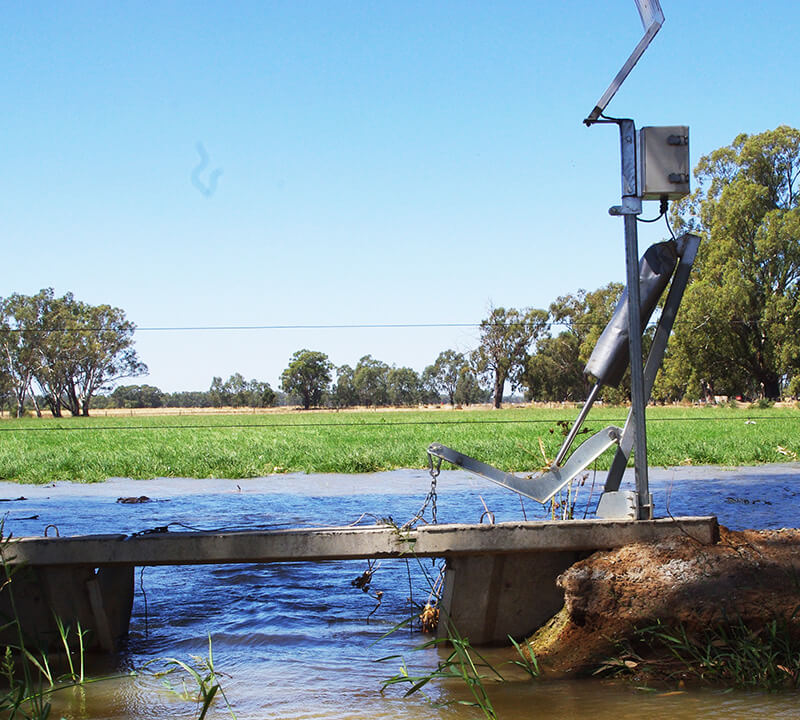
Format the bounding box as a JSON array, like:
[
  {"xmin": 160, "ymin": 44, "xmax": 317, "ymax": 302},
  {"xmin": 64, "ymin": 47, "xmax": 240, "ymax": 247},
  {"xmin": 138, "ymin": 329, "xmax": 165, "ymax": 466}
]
[{"xmin": 0, "ymin": 0, "xmax": 800, "ymax": 391}]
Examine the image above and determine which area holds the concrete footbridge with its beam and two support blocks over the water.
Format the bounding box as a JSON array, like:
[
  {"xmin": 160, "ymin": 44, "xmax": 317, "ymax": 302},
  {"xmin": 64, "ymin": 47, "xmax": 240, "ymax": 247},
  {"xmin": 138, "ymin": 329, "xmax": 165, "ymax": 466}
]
[{"xmin": 0, "ymin": 517, "xmax": 718, "ymax": 651}]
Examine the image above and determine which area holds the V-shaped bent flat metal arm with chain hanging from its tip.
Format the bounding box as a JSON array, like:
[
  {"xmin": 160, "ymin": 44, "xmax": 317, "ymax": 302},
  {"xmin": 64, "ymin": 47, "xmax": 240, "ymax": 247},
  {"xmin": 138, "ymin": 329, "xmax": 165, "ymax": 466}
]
[{"xmin": 428, "ymin": 425, "xmax": 622, "ymax": 503}]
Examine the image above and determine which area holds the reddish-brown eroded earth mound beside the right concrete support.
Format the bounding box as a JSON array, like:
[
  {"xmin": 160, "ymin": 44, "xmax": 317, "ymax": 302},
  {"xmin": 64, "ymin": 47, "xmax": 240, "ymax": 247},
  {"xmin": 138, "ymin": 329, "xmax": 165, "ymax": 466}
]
[{"xmin": 529, "ymin": 527, "xmax": 800, "ymax": 673}]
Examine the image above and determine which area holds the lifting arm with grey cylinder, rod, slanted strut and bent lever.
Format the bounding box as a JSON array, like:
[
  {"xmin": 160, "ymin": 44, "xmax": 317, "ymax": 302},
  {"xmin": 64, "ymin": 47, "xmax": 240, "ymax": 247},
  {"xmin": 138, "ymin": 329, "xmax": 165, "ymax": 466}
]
[{"xmin": 428, "ymin": 233, "xmax": 700, "ymax": 510}]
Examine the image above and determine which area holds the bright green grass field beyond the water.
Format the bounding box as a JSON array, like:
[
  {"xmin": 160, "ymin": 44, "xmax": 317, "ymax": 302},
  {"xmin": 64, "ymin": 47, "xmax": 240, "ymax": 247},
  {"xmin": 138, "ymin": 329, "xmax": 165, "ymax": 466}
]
[{"xmin": 0, "ymin": 406, "xmax": 800, "ymax": 483}]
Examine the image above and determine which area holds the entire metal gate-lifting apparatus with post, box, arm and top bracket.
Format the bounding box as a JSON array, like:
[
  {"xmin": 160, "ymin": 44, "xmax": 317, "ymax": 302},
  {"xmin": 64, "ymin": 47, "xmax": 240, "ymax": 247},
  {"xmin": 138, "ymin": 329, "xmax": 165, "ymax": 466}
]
[{"xmin": 428, "ymin": 0, "xmax": 700, "ymax": 520}]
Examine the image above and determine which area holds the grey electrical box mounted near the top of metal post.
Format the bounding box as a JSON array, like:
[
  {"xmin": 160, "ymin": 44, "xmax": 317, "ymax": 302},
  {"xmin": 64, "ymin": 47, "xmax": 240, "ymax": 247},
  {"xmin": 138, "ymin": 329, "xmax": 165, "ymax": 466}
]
[{"xmin": 637, "ymin": 125, "xmax": 690, "ymax": 200}]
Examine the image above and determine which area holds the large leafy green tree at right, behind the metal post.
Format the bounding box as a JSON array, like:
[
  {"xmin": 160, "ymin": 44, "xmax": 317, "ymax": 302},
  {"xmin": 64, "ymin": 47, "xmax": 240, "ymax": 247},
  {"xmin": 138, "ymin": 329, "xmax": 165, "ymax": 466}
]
[{"xmin": 664, "ymin": 125, "xmax": 800, "ymax": 398}]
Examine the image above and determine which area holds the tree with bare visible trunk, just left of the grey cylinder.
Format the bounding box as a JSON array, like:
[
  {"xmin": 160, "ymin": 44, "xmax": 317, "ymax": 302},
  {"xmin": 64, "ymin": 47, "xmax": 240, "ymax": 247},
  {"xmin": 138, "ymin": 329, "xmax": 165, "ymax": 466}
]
[{"xmin": 472, "ymin": 307, "xmax": 548, "ymax": 408}]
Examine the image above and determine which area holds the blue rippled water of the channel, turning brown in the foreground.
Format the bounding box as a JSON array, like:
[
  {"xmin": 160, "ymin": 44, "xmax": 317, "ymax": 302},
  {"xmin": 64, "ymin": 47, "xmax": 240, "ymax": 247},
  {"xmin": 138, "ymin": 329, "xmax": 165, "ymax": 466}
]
[{"xmin": 0, "ymin": 463, "xmax": 800, "ymax": 720}]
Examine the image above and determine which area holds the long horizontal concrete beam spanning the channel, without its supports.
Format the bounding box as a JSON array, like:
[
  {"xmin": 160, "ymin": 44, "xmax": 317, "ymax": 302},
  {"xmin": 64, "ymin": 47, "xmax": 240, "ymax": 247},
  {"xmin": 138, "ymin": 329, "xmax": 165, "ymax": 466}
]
[{"xmin": 0, "ymin": 517, "xmax": 718, "ymax": 567}]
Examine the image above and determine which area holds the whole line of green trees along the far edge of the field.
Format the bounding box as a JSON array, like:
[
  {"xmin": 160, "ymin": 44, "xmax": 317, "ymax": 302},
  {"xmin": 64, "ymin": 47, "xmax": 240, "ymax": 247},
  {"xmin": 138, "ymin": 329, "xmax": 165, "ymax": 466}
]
[{"xmin": 0, "ymin": 125, "xmax": 800, "ymax": 416}]
